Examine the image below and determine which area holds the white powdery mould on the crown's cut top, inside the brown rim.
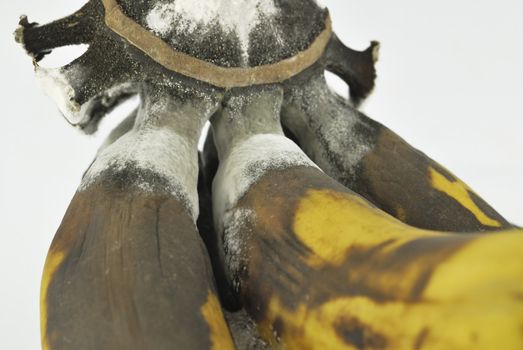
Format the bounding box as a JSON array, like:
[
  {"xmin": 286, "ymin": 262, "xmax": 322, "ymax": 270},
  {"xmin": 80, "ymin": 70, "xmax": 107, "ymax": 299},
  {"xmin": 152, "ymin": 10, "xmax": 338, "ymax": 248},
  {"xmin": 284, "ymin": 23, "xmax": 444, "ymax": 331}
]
[{"xmin": 145, "ymin": 0, "xmax": 278, "ymax": 59}]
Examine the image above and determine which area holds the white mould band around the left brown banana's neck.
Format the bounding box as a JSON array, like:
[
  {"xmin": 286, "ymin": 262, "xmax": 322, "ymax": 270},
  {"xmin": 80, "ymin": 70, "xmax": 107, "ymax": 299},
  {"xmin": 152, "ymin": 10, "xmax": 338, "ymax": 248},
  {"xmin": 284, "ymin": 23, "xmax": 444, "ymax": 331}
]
[{"xmin": 79, "ymin": 127, "xmax": 198, "ymax": 220}]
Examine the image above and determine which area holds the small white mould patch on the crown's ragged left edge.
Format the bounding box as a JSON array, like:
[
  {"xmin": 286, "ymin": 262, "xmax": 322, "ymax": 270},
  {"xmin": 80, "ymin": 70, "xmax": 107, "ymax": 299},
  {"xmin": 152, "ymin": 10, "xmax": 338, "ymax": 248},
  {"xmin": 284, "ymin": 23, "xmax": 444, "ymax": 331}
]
[{"xmin": 35, "ymin": 66, "xmax": 83, "ymax": 125}]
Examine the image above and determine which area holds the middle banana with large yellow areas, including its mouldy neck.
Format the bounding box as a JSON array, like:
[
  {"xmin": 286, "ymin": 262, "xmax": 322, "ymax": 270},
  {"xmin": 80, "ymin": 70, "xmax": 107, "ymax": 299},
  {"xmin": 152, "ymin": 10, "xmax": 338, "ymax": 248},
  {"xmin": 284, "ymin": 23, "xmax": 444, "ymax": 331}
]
[{"xmin": 212, "ymin": 86, "xmax": 523, "ymax": 349}]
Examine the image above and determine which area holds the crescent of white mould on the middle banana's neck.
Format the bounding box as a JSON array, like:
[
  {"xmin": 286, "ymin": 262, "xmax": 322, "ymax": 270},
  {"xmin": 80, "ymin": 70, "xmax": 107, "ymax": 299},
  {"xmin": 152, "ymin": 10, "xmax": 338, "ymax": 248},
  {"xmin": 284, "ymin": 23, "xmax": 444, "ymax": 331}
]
[{"xmin": 213, "ymin": 134, "xmax": 317, "ymax": 232}]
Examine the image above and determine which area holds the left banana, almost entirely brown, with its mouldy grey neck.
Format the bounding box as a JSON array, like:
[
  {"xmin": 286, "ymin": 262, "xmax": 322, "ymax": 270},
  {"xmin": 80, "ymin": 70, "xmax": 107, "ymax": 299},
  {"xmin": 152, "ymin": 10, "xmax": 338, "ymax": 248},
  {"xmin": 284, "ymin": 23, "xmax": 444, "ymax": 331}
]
[{"xmin": 41, "ymin": 87, "xmax": 234, "ymax": 350}]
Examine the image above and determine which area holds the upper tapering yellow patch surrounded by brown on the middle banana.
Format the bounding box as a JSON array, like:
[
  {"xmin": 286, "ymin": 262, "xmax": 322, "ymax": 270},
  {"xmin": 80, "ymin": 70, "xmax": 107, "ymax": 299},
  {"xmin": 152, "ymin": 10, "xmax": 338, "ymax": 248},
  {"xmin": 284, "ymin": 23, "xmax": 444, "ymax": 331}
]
[{"xmin": 293, "ymin": 190, "xmax": 437, "ymax": 267}]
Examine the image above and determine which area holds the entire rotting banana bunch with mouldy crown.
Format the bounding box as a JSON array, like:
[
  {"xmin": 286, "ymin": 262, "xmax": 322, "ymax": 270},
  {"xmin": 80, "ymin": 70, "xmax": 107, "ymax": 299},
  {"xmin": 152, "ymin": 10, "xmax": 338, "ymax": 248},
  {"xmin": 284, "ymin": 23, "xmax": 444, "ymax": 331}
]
[{"xmin": 15, "ymin": 0, "xmax": 523, "ymax": 350}]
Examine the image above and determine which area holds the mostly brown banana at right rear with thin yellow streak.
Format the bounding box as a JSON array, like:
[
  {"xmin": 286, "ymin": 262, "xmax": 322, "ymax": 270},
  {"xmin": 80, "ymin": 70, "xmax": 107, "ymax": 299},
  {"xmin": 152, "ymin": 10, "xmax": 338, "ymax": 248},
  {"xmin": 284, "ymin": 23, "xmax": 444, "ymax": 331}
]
[{"xmin": 282, "ymin": 69, "xmax": 514, "ymax": 232}]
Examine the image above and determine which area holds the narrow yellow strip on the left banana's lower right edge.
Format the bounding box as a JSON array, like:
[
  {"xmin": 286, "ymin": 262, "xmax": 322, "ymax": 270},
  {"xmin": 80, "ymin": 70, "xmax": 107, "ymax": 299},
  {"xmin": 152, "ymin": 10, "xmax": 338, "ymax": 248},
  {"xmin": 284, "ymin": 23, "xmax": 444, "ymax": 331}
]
[{"xmin": 200, "ymin": 291, "xmax": 234, "ymax": 350}]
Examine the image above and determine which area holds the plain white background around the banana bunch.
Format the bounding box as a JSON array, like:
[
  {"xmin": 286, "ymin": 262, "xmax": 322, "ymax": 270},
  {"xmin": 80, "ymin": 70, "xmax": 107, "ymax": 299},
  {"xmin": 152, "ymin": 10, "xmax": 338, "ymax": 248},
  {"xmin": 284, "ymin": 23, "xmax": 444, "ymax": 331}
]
[{"xmin": 0, "ymin": 0, "xmax": 523, "ymax": 350}]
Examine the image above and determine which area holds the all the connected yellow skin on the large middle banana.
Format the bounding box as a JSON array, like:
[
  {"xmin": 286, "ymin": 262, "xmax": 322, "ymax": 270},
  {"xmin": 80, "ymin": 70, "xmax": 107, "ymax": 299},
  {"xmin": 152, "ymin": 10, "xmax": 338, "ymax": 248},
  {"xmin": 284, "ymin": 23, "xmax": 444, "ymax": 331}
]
[{"xmin": 270, "ymin": 190, "xmax": 523, "ymax": 350}]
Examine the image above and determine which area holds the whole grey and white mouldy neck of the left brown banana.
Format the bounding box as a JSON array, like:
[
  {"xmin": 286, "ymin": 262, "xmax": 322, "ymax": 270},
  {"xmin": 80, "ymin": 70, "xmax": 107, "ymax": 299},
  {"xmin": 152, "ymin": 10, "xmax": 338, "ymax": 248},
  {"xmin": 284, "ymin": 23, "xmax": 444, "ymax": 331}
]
[{"xmin": 81, "ymin": 85, "xmax": 219, "ymax": 220}]
